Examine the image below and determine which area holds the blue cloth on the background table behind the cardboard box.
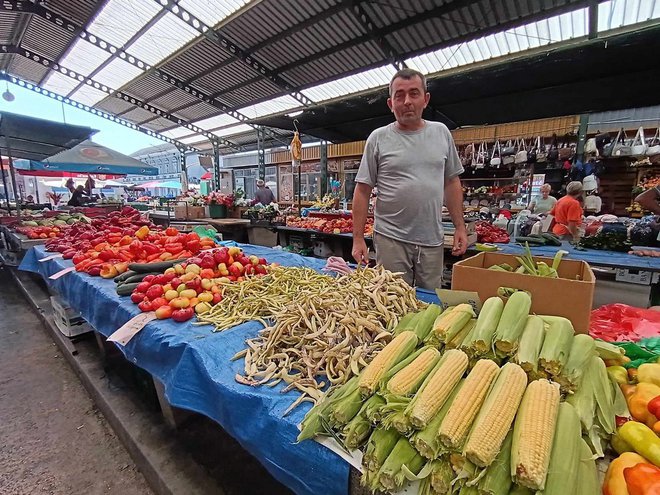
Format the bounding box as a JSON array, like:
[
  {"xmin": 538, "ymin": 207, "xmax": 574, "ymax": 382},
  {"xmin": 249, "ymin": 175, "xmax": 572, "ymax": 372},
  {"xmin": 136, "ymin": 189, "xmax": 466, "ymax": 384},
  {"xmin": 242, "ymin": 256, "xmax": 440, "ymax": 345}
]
[{"xmin": 490, "ymin": 242, "xmax": 660, "ymax": 272}]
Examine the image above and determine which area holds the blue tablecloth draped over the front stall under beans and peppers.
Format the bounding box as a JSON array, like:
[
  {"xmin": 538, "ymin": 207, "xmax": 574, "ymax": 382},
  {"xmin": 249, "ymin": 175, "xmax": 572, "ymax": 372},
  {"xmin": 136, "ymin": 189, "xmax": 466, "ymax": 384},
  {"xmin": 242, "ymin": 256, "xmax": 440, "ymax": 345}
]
[{"xmin": 19, "ymin": 244, "xmax": 437, "ymax": 495}]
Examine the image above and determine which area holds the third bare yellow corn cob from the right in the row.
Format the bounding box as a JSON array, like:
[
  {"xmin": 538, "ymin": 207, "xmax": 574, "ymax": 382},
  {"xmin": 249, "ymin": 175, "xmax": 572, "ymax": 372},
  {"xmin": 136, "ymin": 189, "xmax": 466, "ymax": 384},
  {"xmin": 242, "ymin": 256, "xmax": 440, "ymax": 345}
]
[{"xmin": 438, "ymin": 359, "xmax": 500, "ymax": 450}]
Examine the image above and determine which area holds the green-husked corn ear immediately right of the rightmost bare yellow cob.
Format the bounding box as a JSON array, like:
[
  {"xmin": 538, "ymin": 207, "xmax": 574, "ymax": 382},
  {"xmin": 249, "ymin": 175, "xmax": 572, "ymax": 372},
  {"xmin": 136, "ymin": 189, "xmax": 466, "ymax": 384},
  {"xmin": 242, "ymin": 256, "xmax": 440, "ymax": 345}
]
[{"xmin": 543, "ymin": 402, "xmax": 580, "ymax": 495}]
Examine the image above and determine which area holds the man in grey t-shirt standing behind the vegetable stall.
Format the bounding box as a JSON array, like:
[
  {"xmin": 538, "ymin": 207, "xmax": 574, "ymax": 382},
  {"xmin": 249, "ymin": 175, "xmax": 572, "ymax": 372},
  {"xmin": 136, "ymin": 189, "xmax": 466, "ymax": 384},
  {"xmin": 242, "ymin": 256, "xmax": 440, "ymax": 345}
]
[{"xmin": 352, "ymin": 69, "xmax": 467, "ymax": 290}]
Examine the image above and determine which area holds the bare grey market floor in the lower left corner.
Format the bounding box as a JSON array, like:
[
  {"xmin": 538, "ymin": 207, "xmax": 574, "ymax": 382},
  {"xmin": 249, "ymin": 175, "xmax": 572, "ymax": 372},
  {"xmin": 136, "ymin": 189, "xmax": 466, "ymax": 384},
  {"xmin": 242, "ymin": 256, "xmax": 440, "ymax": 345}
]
[{"xmin": 0, "ymin": 270, "xmax": 153, "ymax": 495}]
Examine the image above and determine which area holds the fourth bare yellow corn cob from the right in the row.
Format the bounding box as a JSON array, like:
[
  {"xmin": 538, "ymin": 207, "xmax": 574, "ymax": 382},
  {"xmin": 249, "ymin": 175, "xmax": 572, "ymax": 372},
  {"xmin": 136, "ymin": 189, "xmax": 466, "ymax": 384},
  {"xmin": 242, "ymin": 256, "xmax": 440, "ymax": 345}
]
[{"xmin": 406, "ymin": 349, "xmax": 468, "ymax": 430}]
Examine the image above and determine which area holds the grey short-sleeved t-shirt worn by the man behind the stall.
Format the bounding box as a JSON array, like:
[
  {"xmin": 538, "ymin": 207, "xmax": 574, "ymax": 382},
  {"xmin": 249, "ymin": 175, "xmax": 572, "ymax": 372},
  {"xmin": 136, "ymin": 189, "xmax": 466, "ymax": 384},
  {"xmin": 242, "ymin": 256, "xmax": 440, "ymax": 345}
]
[{"xmin": 355, "ymin": 121, "xmax": 463, "ymax": 246}]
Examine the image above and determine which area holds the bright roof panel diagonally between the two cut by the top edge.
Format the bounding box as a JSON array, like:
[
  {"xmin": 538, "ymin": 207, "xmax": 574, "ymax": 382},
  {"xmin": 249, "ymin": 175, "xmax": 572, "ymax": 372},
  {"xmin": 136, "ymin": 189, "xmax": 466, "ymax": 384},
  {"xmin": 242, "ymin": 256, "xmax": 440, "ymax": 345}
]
[{"xmin": 126, "ymin": 12, "xmax": 199, "ymax": 65}]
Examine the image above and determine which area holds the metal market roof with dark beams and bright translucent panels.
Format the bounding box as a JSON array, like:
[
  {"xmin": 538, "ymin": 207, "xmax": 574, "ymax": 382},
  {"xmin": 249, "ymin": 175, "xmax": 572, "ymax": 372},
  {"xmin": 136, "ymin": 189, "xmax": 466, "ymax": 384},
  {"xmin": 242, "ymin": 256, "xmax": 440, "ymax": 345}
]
[{"xmin": 0, "ymin": 0, "xmax": 660, "ymax": 153}]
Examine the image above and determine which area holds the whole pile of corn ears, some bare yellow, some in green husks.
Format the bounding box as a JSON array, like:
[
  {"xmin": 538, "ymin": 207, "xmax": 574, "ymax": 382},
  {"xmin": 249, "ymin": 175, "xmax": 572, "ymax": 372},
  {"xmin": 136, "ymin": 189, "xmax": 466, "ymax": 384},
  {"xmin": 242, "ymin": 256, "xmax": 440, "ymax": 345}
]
[{"xmin": 299, "ymin": 292, "xmax": 628, "ymax": 495}]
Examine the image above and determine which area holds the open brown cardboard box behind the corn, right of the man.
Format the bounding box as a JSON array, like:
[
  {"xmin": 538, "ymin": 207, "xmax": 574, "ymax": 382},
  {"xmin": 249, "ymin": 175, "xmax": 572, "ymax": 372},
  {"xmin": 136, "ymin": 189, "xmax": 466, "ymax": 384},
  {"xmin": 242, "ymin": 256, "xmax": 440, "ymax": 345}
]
[{"xmin": 451, "ymin": 253, "xmax": 596, "ymax": 333}]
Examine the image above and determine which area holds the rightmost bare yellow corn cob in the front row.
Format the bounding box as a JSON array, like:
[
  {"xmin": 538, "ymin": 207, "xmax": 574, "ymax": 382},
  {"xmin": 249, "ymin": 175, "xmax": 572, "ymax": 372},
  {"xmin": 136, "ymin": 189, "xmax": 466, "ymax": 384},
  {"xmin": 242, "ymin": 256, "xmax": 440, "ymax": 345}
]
[{"xmin": 511, "ymin": 380, "xmax": 559, "ymax": 490}]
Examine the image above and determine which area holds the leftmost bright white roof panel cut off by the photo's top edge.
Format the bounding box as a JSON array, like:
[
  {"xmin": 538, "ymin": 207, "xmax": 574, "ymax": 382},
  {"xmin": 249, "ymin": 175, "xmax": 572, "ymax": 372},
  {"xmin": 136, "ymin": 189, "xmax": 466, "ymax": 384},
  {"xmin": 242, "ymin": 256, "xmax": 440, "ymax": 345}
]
[{"xmin": 87, "ymin": 0, "xmax": 162, "ymax": 48}]
